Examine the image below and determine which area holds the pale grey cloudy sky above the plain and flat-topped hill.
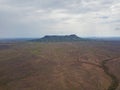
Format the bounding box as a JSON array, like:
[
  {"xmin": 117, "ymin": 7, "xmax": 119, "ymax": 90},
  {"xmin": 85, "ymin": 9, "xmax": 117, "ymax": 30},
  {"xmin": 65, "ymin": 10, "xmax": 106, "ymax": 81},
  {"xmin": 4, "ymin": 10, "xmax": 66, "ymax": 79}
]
[{"xmin": 0, "ymin": 0, "xmax": 120, "ymax": 38}]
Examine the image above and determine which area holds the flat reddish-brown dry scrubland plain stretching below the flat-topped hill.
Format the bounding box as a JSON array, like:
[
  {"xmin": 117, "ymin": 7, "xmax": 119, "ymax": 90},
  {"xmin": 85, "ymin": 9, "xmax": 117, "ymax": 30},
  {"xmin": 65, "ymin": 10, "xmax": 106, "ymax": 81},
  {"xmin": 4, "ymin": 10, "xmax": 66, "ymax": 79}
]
[{"xmin": 0, "ymin": 41, "xmax": 120, "ymax": 90}]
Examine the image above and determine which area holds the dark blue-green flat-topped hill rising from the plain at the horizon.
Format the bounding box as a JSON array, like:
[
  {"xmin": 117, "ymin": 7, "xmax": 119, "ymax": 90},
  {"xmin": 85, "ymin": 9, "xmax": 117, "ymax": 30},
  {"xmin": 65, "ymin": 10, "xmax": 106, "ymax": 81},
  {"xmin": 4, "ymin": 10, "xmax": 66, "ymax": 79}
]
[{"xmin": 32, "ymin": 34, "xmax": 84, "ymax": 42}]
